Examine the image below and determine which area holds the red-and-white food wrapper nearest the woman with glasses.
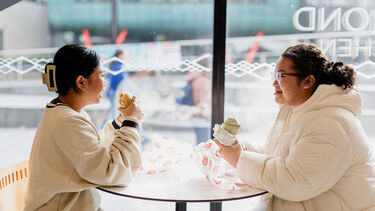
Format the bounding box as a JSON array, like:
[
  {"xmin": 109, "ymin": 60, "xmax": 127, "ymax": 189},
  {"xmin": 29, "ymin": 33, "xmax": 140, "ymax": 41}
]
[{"xmin": 192, "ymin": 140, "xmax": 246, "ymax": 191}]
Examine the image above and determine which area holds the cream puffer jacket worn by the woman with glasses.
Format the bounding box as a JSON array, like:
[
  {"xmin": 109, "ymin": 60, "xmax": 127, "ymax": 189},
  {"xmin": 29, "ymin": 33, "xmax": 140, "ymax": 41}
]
[{"xmin": 237, "ymin": 85, "xmax": 375, "ymax": 211}]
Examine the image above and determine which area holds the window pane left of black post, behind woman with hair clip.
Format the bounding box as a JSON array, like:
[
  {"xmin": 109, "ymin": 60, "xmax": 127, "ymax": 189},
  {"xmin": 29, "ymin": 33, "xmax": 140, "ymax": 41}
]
[{"xmin": 0, "ymin": 0, "xmax": 213, "ymax": 210}]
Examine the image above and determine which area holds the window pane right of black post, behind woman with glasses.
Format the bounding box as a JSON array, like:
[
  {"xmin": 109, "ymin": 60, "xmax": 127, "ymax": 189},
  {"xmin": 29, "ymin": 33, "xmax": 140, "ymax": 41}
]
[{"xmin": 224, "ymin": 0, "xmax": 375, "ymax": 145}]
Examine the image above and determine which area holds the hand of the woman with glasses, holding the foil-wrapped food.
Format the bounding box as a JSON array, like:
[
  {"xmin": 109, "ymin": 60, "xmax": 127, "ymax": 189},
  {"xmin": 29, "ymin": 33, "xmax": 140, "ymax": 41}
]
[{"xmin": 214, "ymin": 139, "xmax": 242, "ymax": 168}]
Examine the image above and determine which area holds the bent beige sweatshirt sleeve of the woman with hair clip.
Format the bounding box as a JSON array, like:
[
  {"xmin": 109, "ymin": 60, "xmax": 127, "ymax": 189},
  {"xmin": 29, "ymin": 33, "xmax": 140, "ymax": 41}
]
[{"xmin": 56, "ymin": 113, "xmax": 142, "ymax": 186}]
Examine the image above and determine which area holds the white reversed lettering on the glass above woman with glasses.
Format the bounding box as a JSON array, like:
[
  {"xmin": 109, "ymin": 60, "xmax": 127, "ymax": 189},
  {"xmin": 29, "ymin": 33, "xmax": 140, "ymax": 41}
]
[{"xmin": 293, "ymin": 7, "xmax": 375, "ymax": 59}]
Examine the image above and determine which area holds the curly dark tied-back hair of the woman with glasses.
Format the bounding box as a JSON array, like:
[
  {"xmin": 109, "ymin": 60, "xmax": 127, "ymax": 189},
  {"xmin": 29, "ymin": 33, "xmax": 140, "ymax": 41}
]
[{"xmin": 281, "ymin": 43, "xmax": 357, "ymax": 89}]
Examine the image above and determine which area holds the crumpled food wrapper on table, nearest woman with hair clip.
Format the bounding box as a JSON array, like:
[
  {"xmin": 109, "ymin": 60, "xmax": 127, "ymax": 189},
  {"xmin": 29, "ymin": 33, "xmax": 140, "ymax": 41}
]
[{"xmin": 140, "ymin": 134, "xmax": 193, "ymax": 174}]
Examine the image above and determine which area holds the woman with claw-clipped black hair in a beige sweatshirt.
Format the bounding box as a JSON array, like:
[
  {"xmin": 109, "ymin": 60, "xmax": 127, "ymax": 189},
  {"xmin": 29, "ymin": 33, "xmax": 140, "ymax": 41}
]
[{"xmin": 24, "ymin": 45, "xmax": 143, "ymax": 211}]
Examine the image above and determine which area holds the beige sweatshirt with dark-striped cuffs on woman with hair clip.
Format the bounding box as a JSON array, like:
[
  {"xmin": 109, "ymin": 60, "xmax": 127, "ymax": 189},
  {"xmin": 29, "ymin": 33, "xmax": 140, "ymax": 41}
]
[{"xmin": 24, "ymin": 101, "xmax": 142, "ymax": 211}]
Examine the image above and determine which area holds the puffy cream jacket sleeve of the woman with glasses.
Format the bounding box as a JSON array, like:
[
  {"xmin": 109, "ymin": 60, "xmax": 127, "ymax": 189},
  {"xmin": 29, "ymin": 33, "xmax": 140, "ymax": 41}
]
[{"xmin": 237, "ymin": 118, "xmax": 351, "ymax": 201}]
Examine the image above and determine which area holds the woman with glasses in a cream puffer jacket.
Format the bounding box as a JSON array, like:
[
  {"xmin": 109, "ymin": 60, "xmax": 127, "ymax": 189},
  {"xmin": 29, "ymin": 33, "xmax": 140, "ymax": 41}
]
[{"xmin": 216, "ymin": 44, "xmax": 375, "ymax": 211}]
